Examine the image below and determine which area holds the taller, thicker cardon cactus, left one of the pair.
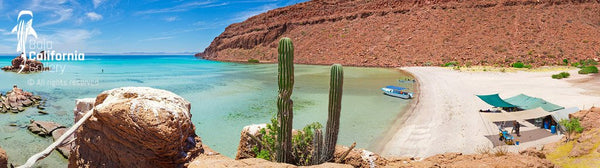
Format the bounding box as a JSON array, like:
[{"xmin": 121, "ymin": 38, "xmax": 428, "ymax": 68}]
[{"xmin": 276, "ymin": 37, "xmax": 294, "ymax": 163}]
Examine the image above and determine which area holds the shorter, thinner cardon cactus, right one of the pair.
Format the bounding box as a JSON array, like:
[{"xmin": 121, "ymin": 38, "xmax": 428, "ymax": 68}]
[{"xmin": 321, "ymin": 64, "xmax": 344, "ymax": 162}]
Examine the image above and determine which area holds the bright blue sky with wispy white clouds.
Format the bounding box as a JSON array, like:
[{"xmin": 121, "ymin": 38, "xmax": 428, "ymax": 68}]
[{"xmin": 0, "ymin": 0, "xmax": 306, "ymax": 53}]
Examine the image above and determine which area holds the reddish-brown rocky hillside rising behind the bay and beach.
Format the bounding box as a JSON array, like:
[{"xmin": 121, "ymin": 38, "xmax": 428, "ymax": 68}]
[{"xmin": 196, "ymin": 0, "xmax": 600, "ymax": 67}]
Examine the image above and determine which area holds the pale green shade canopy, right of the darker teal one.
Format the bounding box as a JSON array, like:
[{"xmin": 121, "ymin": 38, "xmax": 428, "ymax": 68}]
[{"xmin": 504, "ymin": 94, "xmax": 565, "ymax": 111}]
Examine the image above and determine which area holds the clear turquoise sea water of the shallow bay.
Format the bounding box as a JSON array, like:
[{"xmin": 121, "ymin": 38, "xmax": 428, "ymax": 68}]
[{"xmin": 0, "ymin": 56, "xmax": 412, "ymax": 167}]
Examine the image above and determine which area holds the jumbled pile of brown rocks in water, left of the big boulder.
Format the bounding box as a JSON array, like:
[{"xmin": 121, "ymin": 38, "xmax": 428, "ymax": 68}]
[{"xmin": 0, "ymin": 85, "xmax": 45, "ymax": 113}]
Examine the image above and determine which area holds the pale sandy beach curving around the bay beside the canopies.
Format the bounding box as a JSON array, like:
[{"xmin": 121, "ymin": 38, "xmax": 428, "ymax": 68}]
[{"xmin": 376, "ymin": 67, "xmax": 600, "ymax": 157}]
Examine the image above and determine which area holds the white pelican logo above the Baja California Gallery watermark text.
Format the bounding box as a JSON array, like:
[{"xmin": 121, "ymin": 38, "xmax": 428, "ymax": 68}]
[{"xmin": 12, "ymin": 10, "xmax": 37, "ymax": 73}]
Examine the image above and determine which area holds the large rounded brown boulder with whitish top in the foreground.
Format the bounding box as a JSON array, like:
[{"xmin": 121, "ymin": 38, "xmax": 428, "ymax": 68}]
[{"xmin": 69, "ymin": 87, "xmax": 203, "ymax": 167}]
